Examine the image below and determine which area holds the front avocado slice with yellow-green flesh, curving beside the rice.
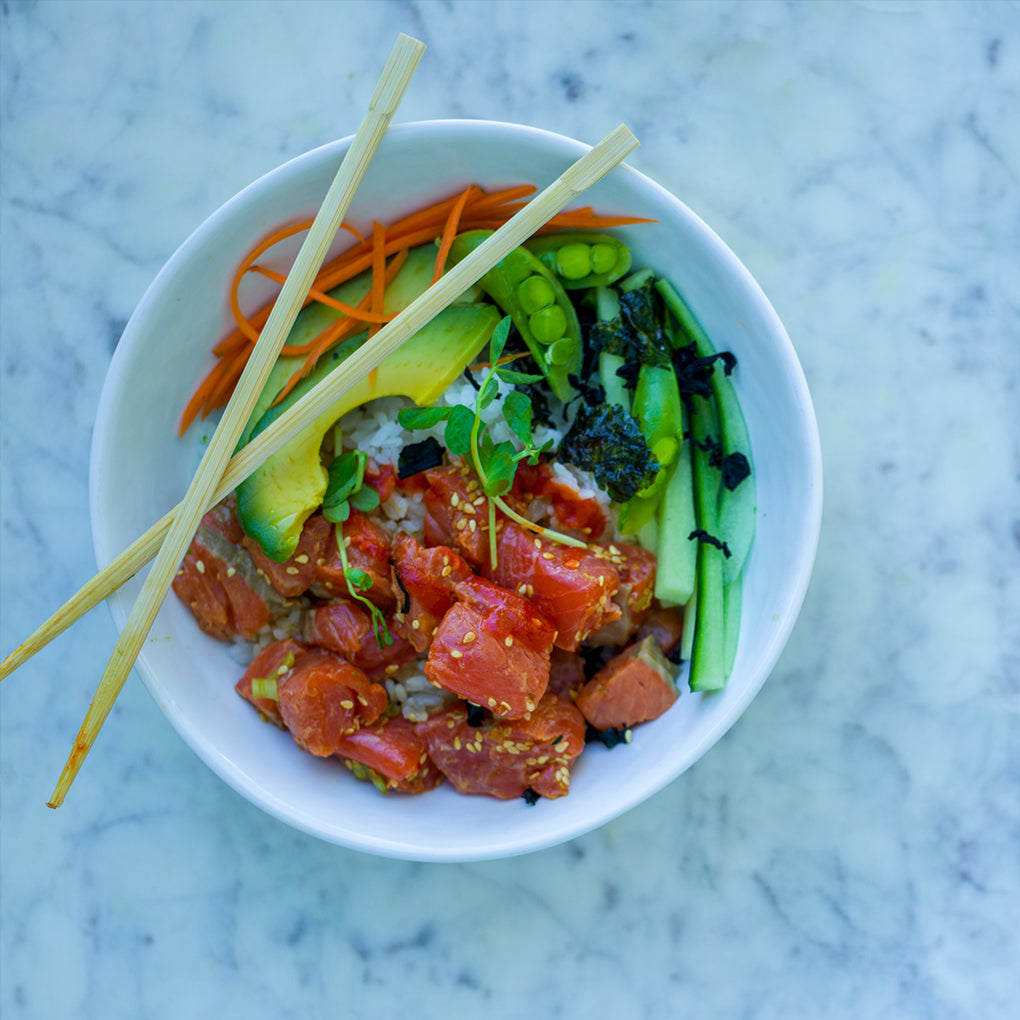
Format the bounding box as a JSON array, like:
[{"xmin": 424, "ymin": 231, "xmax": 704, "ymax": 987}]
[{"xmin": 238, "ymin": 304, "xmax": 500, "ymax": 563}]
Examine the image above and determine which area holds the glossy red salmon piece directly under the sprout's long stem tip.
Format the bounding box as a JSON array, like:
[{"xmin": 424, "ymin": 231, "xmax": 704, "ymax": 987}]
[{"xmin": 493, "ymin": 521, "xmax": 620, "ymax": 652}]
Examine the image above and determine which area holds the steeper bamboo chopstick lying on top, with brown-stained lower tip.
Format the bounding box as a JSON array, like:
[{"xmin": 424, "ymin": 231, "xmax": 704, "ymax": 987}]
[{"xmin": 42, "ymin": 34, "xmax": 424, "ymax": 808}]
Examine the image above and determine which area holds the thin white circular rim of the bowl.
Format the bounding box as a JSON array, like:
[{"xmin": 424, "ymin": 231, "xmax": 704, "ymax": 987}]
[{"xmin": 89, "ymin": 118, "xmax": 822, "ymax": 862}]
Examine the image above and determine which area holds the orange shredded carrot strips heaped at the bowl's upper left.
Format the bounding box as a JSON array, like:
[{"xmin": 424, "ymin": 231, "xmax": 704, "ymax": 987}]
[{"xmin": 180, "ymin": 185, "xmax": 654, "ymax": 434}]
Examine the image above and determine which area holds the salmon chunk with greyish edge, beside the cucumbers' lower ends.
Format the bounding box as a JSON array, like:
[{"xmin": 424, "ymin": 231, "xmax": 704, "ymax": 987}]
[{"xmin": 574, "ymin": 635, "xmax": 677, "ymax": 729}]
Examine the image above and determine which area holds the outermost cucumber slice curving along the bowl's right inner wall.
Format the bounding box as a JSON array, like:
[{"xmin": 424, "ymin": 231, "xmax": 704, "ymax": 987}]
[{"xmin": 656, "ymin": 279, "xmax": 757, "ymax": 584}]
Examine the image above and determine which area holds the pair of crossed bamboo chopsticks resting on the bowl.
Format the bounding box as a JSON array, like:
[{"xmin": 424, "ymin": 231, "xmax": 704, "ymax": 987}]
[{"xmin": 0, "ymin": 35, "xmax": 638, "ymax": 808}]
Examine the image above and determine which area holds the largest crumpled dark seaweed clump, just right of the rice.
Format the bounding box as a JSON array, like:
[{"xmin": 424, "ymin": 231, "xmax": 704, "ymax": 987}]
[{"xmin": 559, "ymin": 403, "xmax": 659, "ymax": 503}]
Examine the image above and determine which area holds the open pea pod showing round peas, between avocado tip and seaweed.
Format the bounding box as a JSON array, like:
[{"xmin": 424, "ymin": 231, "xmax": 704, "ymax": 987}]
[{"xmin": 450, "ymin": 231, "xmax": 581, "ymax": 402}]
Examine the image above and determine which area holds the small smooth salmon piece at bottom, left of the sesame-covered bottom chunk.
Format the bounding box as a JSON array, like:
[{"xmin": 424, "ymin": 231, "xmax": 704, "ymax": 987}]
[{"xmin": 337, "ymin": 715, "xmax": 443, "ymax": 794}]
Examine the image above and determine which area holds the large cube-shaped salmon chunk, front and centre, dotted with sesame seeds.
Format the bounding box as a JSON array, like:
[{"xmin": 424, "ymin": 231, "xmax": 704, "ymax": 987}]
[{"xmin": 425, "ymin": 577, "xmax": 556, "ymax": 718}]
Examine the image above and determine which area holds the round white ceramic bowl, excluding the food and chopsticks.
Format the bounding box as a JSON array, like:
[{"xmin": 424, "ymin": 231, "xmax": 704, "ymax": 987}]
[{"xmin": 91, "ymin": 120, "xmax": 821, "ymax": 861}]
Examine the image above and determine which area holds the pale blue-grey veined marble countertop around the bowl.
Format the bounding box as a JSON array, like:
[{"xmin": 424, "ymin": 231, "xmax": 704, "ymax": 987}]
[{"xmin": 0, "ymin": 0, "xmax": 1020, "ymax": 1020}]
